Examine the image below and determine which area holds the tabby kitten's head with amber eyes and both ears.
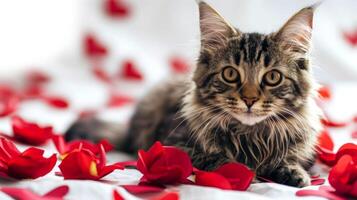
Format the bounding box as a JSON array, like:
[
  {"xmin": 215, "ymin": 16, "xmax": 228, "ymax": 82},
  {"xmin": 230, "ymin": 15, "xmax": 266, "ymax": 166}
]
[{"xmin": 193, "ymin": 2, "xmax": 314, "ymax": 125}]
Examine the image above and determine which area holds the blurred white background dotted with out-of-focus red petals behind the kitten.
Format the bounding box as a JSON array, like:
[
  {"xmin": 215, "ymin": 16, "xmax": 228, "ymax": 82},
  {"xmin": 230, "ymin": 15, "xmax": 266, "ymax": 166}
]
[{"xmin": 0, "ymin": 0, "xmax": 357, "ymax": 132}]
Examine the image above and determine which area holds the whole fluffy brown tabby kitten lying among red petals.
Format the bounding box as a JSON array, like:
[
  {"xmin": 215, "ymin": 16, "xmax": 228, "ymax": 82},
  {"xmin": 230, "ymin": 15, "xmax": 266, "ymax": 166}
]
[{"xmin": 66, "ymin": 2, "xmax": 320, "ymax": 187}]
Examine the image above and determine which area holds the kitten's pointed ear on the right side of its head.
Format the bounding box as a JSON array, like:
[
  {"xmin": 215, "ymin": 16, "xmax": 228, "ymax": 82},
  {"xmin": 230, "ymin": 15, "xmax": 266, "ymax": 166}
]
[{"xmin": 276, "ymin": 5, "xmax": 317, "ymax": 56}]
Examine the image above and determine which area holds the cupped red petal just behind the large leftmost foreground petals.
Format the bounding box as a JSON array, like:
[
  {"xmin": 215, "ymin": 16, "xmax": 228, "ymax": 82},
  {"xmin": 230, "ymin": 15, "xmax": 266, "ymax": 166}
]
[{"xmin": 11, "ymin": 116, "xmax": 54, "ymax": 145}]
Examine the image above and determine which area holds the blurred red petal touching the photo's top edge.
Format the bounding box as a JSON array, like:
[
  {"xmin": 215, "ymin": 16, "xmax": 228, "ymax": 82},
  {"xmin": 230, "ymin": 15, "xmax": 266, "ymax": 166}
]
[{"xmin": 104, "ymin": 0, "xmax": 130, "ymax": 18}]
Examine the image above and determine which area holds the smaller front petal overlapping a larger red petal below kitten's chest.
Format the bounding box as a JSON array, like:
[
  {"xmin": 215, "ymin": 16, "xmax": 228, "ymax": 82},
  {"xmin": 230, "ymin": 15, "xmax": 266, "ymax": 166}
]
[{"xmin": 195, "ymin": 171, "xmax": 232, "ymax": 190}]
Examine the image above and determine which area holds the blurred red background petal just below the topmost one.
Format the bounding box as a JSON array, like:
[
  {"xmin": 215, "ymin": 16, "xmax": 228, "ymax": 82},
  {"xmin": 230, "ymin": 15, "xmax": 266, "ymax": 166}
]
[{"xmin": 84, "ymin": 34, "xmax": 108, "ymax": 58}]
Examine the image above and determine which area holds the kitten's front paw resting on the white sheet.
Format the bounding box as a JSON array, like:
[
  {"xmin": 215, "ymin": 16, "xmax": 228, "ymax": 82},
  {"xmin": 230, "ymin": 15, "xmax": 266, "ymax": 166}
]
[{"xmin": 271, "ymin": 165, "xmax": 311, "ymax": 187}]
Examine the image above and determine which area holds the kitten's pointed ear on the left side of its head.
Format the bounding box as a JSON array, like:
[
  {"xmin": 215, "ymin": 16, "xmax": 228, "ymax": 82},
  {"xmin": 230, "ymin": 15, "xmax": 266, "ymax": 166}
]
[{"xmin": 199, "ymin": 1, "xmax": 237, "ymax": 49}]
